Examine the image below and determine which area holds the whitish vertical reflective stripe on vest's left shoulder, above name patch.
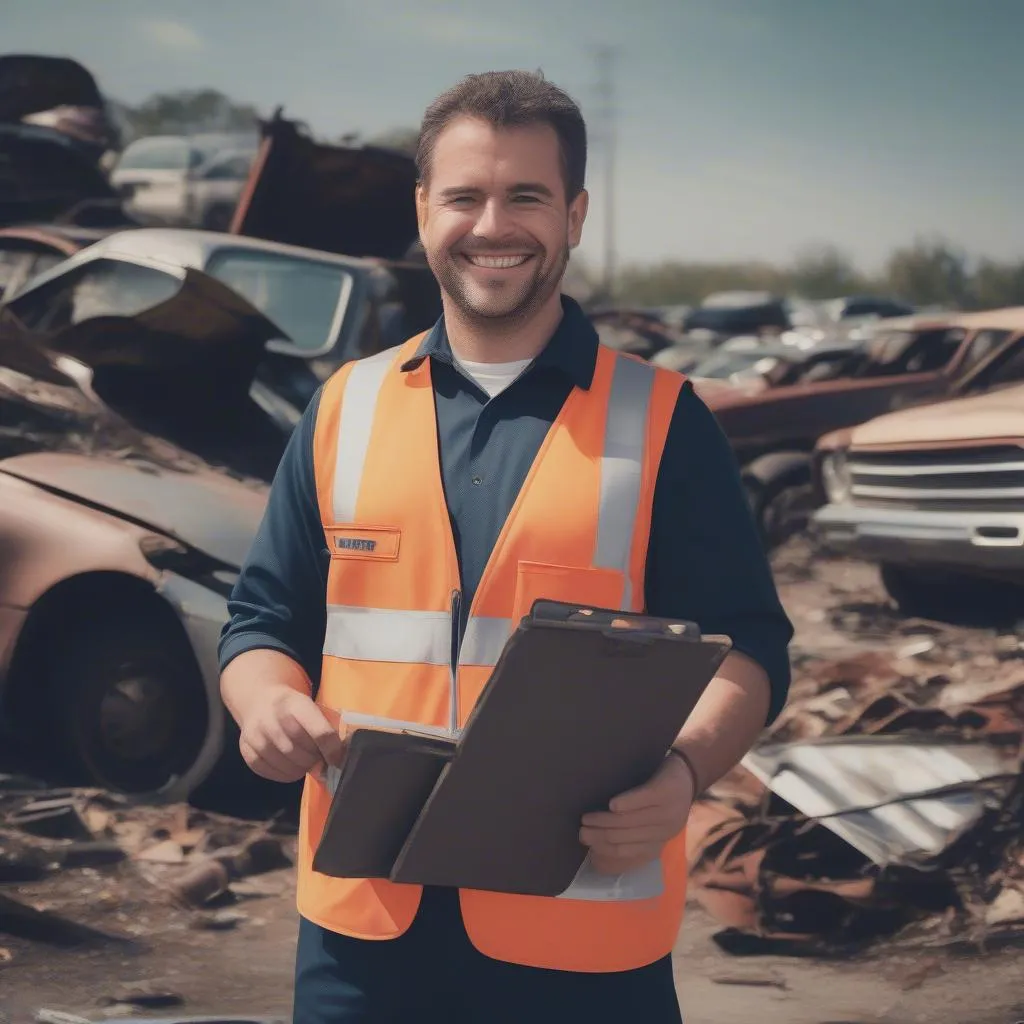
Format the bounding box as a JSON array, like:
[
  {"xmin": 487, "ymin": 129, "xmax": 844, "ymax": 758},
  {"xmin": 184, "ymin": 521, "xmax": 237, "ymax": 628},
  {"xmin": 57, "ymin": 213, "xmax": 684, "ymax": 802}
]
[{"xmin": 334, "ymin": 348, "xmax": 398, "ymax": 523}]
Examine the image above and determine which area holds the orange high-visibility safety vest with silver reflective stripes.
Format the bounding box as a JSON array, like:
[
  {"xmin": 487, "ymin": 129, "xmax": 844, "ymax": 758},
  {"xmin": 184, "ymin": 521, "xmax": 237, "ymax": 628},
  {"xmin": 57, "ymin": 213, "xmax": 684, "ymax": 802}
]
[{"xmin": 298, "ymin": 336, "xmax": 687, "ymax": 972}]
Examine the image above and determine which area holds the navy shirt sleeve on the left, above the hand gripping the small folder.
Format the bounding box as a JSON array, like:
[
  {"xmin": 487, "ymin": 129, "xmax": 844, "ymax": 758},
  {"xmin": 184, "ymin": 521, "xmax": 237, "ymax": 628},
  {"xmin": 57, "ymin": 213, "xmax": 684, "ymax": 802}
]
[{"xmin": 219, "ymin": 391, "xmax": 329, "ymax": 689}]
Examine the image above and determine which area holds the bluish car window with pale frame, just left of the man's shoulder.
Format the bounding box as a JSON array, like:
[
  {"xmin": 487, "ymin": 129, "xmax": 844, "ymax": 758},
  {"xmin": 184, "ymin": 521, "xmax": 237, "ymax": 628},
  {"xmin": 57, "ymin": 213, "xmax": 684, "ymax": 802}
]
[{"xmin": 206, "ymin": 249, "xmax": 350, "ymax": 352}]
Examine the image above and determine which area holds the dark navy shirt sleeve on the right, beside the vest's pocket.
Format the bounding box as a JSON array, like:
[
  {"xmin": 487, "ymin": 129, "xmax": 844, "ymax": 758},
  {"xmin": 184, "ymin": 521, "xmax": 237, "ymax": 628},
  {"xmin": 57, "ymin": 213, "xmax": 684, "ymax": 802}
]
[{"xmin": 646, "ymin": 385, "xmax": 793, "ymax": 722}]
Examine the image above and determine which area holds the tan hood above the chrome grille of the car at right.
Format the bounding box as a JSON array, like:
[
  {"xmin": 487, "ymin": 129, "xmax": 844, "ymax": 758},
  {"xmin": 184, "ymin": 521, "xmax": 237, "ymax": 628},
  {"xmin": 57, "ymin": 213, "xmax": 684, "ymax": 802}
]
[{"xmin": 851, "ymin": 385, "xmax": 1024, "ymax": 446}]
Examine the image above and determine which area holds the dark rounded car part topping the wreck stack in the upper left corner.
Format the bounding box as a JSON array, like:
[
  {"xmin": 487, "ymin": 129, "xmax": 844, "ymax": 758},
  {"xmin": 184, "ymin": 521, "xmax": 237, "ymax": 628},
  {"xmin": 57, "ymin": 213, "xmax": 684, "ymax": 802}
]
[{"xmin": 0, "ymin": 53, "xmax": 103, "ymax": 122}]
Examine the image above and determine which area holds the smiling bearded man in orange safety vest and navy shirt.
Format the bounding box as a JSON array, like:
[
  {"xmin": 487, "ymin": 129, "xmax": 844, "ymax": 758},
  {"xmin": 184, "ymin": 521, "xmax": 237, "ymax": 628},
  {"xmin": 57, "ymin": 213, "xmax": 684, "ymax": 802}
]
[{"xmin": 221, "ymin": 72, "xmax": 792, "ymax": 1024}]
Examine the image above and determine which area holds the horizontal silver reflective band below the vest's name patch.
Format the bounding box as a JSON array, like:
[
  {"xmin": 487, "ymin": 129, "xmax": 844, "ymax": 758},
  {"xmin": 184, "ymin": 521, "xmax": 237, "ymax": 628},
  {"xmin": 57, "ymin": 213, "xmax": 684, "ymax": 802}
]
[{"xmin": 324, "ymin": 604, "xmax": 452, "ymax": 665}]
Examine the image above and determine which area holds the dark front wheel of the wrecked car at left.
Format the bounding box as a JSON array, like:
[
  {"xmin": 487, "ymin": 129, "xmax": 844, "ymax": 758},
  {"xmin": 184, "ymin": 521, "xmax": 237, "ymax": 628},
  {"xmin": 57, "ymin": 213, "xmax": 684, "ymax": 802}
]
[{"xmin": 47, "ymin": 610, "xmax": 209, "ymax": 794}]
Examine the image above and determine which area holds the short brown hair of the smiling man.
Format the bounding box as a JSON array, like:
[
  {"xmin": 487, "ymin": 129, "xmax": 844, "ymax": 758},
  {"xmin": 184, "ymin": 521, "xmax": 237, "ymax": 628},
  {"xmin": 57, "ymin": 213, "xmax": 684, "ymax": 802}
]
[{"xmin": 416, "ymin": 71, "xmax": 587, "ymax": 200}]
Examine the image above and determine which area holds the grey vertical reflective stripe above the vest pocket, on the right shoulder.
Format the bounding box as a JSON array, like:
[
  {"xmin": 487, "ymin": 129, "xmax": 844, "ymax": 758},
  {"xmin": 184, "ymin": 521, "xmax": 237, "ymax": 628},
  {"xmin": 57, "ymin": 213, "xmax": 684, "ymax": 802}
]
[{"xmin": 594, "ymin": 356, "xmax": 654, "ymax": 608}]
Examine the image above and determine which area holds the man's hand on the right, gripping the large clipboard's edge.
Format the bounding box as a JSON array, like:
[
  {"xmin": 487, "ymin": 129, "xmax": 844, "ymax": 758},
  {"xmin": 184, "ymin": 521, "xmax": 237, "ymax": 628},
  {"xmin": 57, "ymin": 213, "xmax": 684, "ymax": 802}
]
[{"xmin": 580, "ymin": 755, "xmax": 694, "ymax": 874}]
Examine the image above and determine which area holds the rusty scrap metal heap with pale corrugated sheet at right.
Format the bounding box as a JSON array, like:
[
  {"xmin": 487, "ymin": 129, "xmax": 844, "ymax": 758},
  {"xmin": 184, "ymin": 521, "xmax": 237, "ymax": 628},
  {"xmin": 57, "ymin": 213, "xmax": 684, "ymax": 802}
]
[{"xmin": 688, "ymin": 635, "xmax": 1024, "ymax": 955}]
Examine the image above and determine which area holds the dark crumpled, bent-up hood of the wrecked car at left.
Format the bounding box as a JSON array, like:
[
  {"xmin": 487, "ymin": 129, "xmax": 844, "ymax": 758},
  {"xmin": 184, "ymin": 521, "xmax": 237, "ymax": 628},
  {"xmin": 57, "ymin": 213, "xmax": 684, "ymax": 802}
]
[{"xmin": 0, "ymin": 270, "xmax": 289, "ymax": 478}]
